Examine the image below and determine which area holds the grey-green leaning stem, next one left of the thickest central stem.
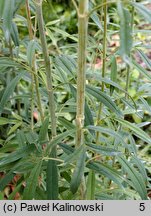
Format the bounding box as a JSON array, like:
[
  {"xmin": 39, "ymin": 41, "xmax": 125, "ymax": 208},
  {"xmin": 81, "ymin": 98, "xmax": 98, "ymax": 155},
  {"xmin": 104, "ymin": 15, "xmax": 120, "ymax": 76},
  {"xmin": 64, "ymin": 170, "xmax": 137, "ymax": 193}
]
[{"xmin": 35, "ymin": 0, "xmax": 56, "ymax": 139}]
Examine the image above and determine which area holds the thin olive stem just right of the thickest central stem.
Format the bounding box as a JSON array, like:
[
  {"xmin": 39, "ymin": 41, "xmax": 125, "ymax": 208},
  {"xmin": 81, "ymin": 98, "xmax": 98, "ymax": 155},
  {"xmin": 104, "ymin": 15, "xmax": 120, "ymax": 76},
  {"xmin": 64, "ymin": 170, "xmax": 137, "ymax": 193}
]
[{"xmin": 96, "ymin": 0, "xmax": 107, "ymax": 144}]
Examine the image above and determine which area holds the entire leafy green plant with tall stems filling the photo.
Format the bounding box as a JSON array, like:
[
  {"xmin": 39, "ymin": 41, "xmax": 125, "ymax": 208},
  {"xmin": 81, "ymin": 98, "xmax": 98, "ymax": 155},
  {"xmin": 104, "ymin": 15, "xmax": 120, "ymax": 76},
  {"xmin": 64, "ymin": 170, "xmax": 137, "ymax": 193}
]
[{"xmin": 0, "ymin": 0, "xmax": 151, "ymax": 200}]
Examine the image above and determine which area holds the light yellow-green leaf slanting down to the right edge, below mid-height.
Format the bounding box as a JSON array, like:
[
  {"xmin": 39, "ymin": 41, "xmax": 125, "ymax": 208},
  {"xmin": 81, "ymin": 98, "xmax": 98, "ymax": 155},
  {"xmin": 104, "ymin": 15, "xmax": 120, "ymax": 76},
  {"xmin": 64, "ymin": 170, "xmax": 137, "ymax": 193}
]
[{"xmin": 115, "ymin": 118, "xmax": 151, "ymax": 144}]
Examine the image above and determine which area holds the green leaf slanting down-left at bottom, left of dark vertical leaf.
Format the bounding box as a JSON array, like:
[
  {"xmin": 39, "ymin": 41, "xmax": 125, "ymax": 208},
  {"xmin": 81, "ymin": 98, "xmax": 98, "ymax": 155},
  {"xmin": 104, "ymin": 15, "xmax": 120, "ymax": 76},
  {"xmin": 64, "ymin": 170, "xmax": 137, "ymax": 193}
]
[{"xmin": 23, "ymin": 161, "xmax": 42, "ymax": 200}]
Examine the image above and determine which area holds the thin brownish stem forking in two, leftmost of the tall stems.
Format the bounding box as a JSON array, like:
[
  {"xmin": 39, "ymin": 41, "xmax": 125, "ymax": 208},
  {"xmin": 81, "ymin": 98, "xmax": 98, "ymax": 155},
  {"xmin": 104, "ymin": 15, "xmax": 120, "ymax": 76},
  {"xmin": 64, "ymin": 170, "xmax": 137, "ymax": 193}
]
[{"xmin": 26, "ymin": 0, "xmax": 44, "ymax": 126}]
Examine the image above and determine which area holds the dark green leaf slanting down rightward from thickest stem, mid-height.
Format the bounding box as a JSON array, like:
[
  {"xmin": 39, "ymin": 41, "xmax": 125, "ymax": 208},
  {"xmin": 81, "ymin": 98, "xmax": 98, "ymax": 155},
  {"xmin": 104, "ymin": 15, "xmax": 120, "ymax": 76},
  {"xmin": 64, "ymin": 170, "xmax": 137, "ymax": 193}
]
[{"xmin": 86, "ymin": 85, "xmax": 122, "ymax": 116}]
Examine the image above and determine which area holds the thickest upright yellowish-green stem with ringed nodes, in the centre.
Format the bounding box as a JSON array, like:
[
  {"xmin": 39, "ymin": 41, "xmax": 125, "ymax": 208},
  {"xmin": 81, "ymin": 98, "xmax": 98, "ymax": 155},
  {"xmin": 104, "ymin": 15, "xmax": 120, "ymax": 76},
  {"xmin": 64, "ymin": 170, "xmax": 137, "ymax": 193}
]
[{"xmin": 76, "ymin": 0, "xmax": 88, "ymax": 147}]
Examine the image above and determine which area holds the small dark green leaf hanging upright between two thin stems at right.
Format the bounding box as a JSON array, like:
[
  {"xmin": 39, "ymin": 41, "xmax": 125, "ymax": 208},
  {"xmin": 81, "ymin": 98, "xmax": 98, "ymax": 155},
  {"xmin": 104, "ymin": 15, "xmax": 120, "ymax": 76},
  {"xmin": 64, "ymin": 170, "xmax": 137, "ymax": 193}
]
[{"xmin": 110, "ymin": 56, "xmax": 117, "ymax": 95}]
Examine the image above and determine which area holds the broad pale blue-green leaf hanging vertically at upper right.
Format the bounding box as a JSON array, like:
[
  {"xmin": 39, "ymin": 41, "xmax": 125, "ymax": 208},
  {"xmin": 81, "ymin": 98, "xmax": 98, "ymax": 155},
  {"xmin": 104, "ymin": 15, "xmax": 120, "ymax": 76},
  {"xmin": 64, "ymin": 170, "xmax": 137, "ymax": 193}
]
[{"xmin": 117, "ymin": 2, "xmax": 133, "ymax": 58}]
